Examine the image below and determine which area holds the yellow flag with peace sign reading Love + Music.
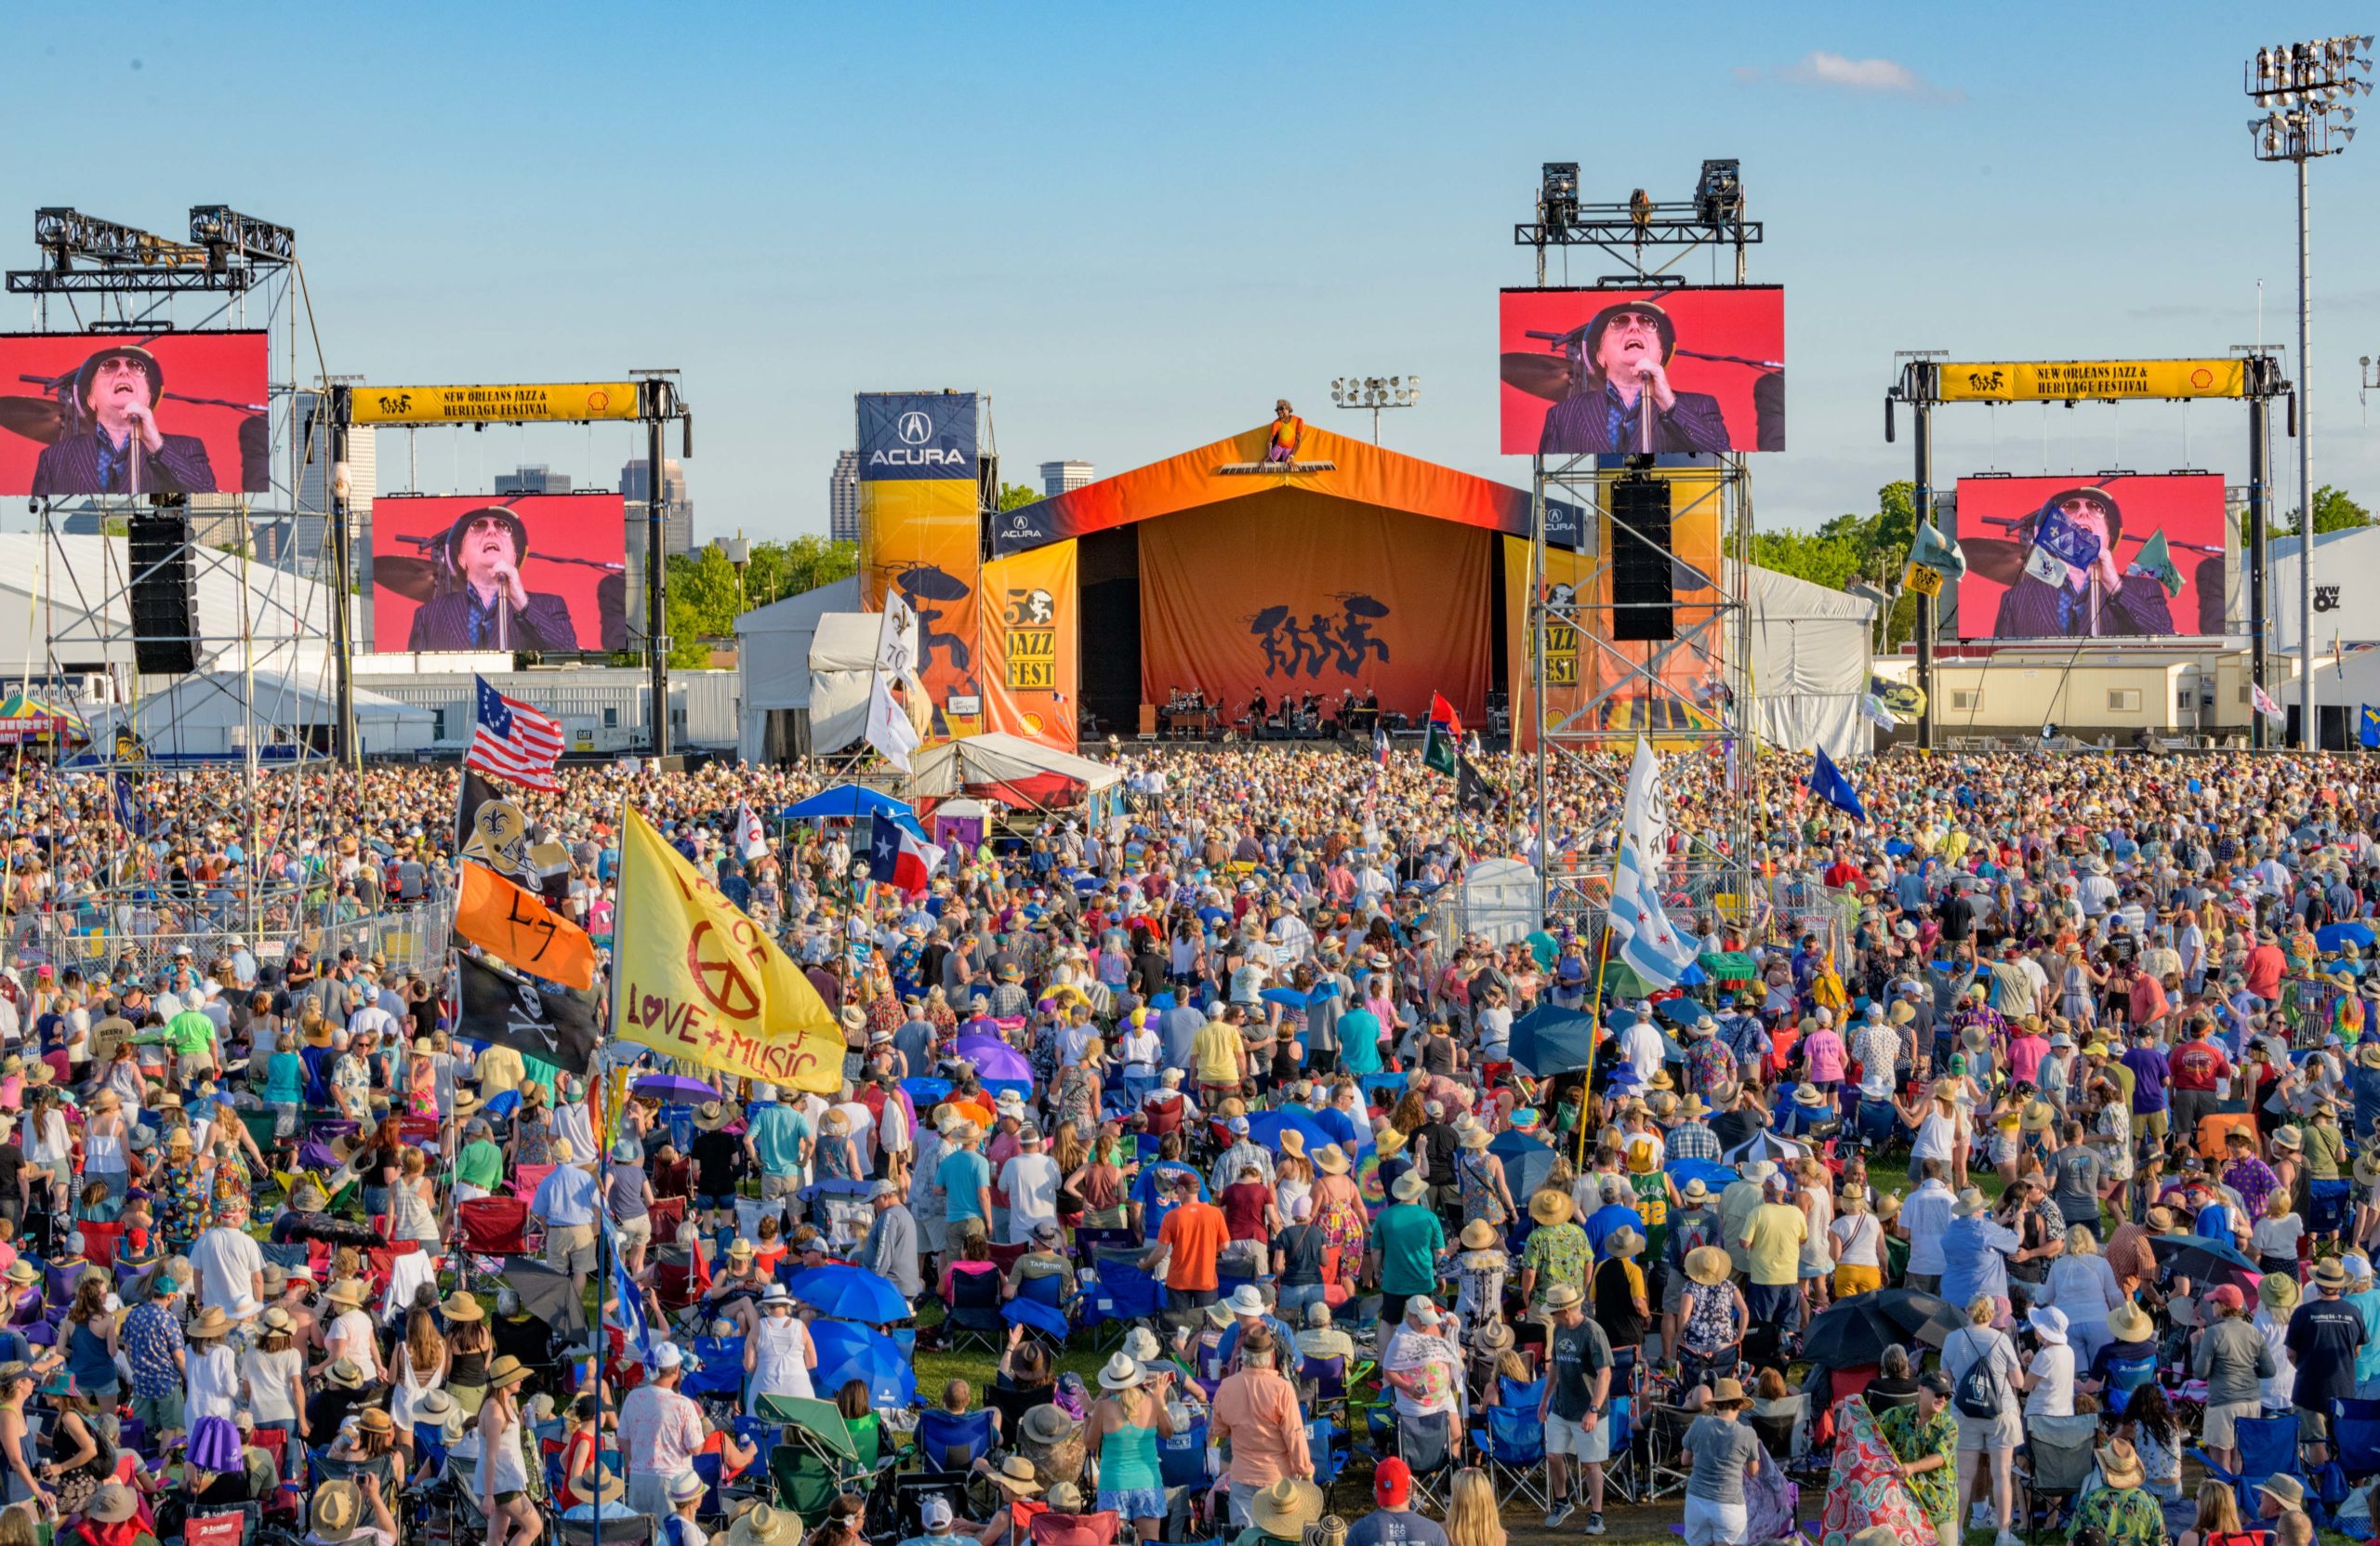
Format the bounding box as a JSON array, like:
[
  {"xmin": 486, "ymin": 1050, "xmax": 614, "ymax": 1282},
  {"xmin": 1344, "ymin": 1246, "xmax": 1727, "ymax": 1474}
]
[{"xmin": 612, "ymin": 811, "xmax": 842, "ymax": 1094}]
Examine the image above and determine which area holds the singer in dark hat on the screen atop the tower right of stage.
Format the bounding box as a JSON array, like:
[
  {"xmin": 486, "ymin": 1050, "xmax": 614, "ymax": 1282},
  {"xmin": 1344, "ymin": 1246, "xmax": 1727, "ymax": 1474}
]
[{"xmin": 1538, "ymin": 299, "xmax": 1728, "ymax": 456}]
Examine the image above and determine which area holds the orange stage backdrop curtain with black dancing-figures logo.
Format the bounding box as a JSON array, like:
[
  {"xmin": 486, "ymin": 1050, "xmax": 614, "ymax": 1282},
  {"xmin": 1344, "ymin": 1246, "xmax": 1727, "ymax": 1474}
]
[{"xmin": 1132, "ymin": 487, "xmax": 1495, "ymax": 723}]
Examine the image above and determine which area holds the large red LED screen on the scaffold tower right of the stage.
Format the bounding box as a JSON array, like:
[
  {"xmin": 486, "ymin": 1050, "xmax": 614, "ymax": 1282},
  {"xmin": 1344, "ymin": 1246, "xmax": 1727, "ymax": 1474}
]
[{"xmin": 1497, "ymin": 285, "xmax": 1785, "ymax": 456}]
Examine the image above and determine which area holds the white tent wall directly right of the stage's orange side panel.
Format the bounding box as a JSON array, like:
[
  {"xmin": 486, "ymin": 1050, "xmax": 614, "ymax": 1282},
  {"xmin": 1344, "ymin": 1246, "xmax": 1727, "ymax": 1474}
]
[{"xmin": 1750, "ymin": 568, "xmax": 1875, "ymax": 763}]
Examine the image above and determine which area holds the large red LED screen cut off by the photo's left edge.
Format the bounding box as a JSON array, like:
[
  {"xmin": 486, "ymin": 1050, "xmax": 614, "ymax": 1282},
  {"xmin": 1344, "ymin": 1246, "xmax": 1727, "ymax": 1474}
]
[{"xmin": 0, "ymin": 333, "xmax": 273, "ymax": 499}]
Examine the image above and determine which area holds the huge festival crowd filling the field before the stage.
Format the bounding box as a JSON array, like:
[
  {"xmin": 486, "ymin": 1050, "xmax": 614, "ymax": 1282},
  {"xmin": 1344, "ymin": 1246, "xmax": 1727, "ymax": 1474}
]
[{"xmin": 0, "ymin": 747, "xmax": 2380, "ymax": 1546}]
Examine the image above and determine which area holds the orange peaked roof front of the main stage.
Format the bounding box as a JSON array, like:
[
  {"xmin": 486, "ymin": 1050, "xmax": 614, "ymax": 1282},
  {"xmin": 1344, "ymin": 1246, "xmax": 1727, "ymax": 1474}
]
[{"xmin": 990, "ymin": 423, "xmax": 1580, "ymax": 554}]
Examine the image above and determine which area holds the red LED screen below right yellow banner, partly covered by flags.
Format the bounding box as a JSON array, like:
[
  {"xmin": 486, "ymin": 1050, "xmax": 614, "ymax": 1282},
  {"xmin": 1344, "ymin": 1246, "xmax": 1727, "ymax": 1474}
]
[{"xmin": 1959, "ymin": 473, "xmax": 2228, "ymax": 640}]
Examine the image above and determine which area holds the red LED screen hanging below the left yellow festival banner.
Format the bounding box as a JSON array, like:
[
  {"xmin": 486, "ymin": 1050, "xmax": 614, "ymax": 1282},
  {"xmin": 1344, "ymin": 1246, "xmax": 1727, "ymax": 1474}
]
[{"xmin": 371, "ymin": 495, "xmax": 628, "ymax": 654}]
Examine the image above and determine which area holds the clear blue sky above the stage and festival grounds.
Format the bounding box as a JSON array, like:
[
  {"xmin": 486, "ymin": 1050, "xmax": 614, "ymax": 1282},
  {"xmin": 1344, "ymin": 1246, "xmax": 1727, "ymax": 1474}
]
[{"xmin": 0, "ymin": 0, "xmax": 2380, "ymax": 537}]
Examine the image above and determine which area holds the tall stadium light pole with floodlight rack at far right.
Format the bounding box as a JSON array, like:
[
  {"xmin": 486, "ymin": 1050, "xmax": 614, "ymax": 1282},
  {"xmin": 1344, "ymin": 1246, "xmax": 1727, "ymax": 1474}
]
[{"xmin": 2247, "ymin": 33, "xmax": 2373, "ymax": 751}]
